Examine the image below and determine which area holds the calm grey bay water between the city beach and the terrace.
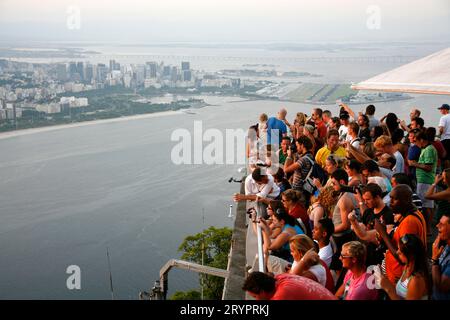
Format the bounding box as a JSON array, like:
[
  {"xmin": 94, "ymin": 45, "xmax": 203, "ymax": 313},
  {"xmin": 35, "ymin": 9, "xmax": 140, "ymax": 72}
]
[{"xmin": 0, "ymin": 43, "xmax": 449, "ymax": 299}]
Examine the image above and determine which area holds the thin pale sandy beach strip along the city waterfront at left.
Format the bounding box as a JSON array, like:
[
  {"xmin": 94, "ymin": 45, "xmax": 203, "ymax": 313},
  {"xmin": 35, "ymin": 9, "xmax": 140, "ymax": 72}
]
[{"xmin": 0, "ymin": 109, "xmax": 181, "ymax": 140}]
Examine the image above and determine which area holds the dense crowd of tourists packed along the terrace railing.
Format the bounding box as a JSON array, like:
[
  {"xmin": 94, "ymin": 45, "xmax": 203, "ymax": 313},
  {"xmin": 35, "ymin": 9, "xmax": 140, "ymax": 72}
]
[{"xmin": 237, "ymin": 103, "xmax": 450, "ymax": 300}]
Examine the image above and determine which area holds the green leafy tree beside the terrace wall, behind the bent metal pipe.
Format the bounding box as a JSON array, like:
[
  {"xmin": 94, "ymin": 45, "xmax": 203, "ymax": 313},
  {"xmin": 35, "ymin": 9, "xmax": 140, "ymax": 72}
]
[{"xmin": 174, "ymin": 227, "xmax": 233, "ymax": 300}]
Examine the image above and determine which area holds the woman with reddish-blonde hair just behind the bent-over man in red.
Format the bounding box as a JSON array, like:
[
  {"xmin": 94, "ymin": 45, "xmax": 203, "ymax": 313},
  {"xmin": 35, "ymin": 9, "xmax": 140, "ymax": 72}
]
[{"xmin": 288, "ymin": 234, "xmax": 334, "ymax": 292}]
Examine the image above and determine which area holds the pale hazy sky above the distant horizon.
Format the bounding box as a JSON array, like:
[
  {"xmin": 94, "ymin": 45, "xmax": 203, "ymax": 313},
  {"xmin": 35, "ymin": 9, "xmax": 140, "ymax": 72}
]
[{"xmin": 0, "ymin": 0, "xmax": 450, "ymax": 43}]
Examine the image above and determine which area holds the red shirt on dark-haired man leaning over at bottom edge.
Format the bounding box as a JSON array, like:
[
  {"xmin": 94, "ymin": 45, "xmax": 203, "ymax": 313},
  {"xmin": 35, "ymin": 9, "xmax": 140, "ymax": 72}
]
[{"xmin": 270, "ymin": 273, "xmax": 336, "ymax": 300}]
